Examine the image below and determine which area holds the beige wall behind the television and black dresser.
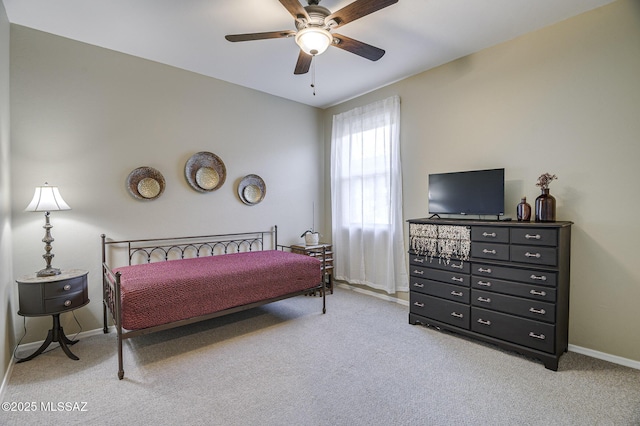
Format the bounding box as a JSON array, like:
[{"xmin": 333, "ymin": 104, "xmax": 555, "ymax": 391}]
[{"xmin": 325, "ymin": 0, "xmax": 640, "ymax": 361}]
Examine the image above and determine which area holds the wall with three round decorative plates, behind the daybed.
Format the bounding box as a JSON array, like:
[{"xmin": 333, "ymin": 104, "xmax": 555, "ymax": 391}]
[{"xmin": 11, "ymin": 25, "xmax": 325, "ymax": 342}]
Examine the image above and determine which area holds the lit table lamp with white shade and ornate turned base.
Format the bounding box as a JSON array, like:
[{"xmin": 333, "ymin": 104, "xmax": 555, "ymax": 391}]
[{"xmin": 25, "ymin": 182, "xmax": 71, "ymax": 277}]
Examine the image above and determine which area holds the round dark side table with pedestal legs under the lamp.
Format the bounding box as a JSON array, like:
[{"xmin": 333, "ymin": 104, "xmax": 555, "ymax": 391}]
[{"xmin": 16, "ymin": 269, "xmax": 89, "ymax": 362}]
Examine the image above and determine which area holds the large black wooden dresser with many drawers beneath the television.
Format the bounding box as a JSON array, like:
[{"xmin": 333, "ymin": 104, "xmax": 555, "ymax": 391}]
[{"xmin": 408, "ymin": 219, "xmax": 572, "ymax": 370}]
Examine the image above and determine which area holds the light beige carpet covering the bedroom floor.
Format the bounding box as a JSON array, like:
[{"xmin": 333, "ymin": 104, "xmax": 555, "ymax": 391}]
[{"xmin": 0, "ymin": 288, "xmax": 640, "ymax": 426}]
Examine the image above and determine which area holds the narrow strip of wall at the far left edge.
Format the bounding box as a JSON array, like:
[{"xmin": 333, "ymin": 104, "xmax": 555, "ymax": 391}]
[{"xmin": 0, "ymin": 1, "xmax": 15, "ymax": 381}]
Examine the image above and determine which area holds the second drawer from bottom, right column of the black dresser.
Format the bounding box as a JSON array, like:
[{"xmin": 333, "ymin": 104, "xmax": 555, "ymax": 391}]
[{"xmin": 471, "ymin": 289, "xmax": 556, "ymax": 322}]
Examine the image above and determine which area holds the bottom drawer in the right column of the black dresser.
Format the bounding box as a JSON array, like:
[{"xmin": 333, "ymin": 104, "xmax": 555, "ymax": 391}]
[{"xmin": 471, "ymin": 307, "xmax": 555, "ymax": 353}]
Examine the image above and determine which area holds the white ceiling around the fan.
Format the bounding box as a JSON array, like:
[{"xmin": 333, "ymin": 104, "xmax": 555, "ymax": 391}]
[{"xmin": 1, "ymin": 0, "xmax": 614, "ymax": 108}]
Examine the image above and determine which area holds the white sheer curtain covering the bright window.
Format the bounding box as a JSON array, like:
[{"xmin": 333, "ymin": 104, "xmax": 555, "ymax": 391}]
[{"xmin": 331, "ymin": 96, "xmax": 409, "ymax": 294}]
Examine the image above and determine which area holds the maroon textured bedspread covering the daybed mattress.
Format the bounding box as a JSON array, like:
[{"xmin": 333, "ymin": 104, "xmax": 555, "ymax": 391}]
[{"xmin": 114, "ymin": 250, "xmax": 322, "ymax": 330}]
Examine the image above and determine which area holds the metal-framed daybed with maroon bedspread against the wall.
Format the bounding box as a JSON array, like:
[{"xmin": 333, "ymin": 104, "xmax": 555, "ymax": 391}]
[{"xmin": 101, "ymin": 226, "xmax": 326, "ymax": 380}]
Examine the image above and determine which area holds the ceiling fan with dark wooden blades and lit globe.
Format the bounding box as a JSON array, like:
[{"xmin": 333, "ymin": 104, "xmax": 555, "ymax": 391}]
[{"xmin": 225, "ymin": 0, "xmax": 398, "ymax": 74}]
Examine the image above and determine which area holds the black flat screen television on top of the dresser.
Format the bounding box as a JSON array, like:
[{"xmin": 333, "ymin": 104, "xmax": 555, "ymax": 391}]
[{"xmin": 429, "ymin": 169, "xmax": 504, "ymax": 216}]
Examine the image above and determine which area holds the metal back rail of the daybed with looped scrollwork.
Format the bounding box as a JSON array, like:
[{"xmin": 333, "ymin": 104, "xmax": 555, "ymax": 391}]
[{"xmin": 101, "ymin": 226, "xmax": 278, "ymax": 265}]
